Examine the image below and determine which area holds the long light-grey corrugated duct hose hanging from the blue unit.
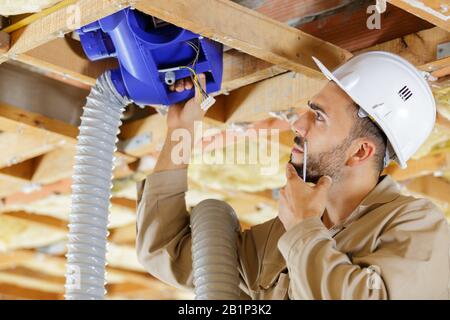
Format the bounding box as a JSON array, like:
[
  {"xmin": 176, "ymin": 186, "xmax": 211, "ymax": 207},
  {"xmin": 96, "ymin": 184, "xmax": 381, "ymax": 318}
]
[{"xmin": 65, "ymin": 72, "xmax": 129, "ymax": 300}]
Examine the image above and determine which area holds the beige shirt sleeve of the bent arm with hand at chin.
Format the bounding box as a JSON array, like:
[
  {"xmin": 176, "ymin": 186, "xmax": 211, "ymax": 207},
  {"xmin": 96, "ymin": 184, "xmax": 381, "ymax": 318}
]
[{"xmin": 278, "ymin": 202, "xmax": 449, "ymax": 299}]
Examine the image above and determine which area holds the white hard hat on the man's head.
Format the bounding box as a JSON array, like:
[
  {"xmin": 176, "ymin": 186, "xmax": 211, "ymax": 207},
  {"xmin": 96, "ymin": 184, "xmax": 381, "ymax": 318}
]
[{"xmin": 313, "ymin": 51, "xmax": 436, "ymax": 168}]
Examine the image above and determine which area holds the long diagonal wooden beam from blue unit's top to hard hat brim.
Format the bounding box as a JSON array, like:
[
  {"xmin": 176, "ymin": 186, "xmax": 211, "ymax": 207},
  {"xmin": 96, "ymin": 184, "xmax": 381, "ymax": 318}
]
[{"xmin": 135, "ymin": 0, "xmax": 351, "ymax": 76}]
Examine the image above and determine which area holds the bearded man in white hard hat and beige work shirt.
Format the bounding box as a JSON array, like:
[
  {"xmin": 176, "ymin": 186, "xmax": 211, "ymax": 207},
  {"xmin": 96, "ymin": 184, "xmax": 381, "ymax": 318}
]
[{"xmin": 137, "ymin": 52, "xmax": 450, "ymax": 299}]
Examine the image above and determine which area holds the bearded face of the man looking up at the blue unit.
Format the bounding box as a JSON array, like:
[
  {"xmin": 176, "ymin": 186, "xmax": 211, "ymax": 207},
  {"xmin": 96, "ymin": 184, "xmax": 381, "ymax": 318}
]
[{"xmin": 291, "ymin": 81, "xmax": 356, "ymax": 183}]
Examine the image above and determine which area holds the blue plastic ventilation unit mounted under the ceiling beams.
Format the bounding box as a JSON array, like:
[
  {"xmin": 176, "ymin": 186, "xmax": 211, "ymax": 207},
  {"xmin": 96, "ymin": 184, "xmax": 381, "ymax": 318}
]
[{"xmin": 78, "ymin": 8, "xmax": 223, "ymax": 105}]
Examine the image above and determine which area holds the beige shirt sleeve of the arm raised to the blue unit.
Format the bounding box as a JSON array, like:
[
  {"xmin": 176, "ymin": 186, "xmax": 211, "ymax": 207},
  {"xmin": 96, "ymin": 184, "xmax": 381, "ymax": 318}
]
[{"xmin": 136, "ymin": 169, "xmax": 193, "ymax": 289}]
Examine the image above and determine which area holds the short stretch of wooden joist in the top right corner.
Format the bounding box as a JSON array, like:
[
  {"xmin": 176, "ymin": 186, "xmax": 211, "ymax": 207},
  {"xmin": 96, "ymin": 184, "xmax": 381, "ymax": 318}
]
[{"xmin": 388, "ymin": 0, "xmax": 450, "ymax": 31}]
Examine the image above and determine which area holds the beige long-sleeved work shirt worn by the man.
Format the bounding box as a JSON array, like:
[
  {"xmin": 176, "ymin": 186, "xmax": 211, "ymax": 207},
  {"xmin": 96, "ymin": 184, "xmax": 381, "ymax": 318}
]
[{"xmin": 136, "ymin": 170, "xmax": 450, "ymax": 299}]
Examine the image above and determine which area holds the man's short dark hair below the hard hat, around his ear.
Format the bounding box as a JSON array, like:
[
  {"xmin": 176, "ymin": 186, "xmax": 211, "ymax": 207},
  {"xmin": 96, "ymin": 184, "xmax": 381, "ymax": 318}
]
[{"xmin": 350, "ymin": 103, "xmax": 387, "ymax": 175}]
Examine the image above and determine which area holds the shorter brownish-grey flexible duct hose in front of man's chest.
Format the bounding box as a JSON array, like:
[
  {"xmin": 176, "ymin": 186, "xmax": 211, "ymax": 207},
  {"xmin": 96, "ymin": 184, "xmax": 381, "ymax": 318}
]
[{"xmin": 191, "ymin": 199, "xmax": 239, "ymax": 300}]
